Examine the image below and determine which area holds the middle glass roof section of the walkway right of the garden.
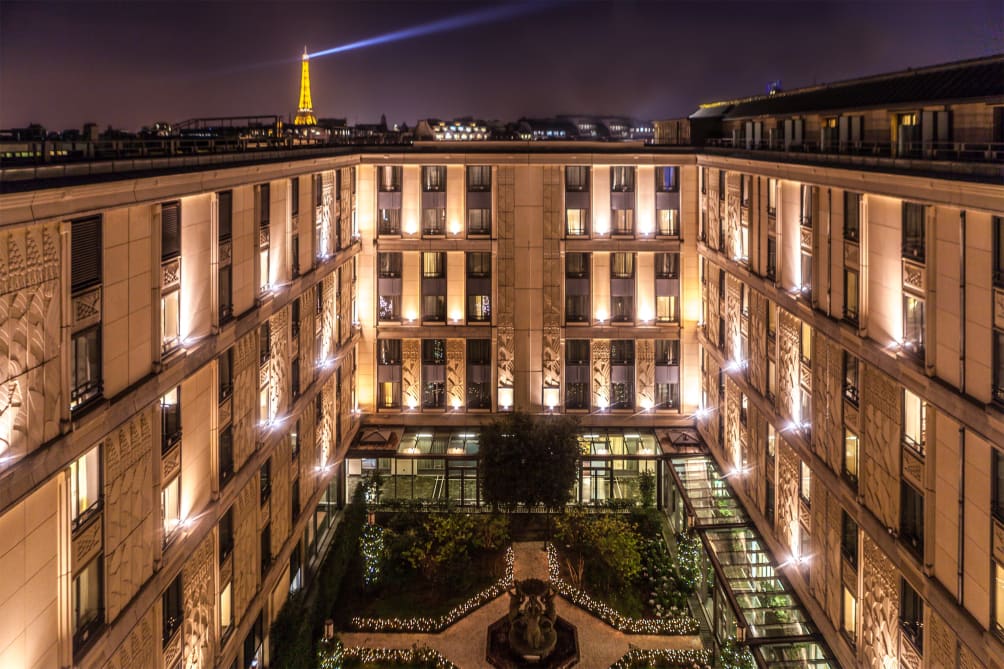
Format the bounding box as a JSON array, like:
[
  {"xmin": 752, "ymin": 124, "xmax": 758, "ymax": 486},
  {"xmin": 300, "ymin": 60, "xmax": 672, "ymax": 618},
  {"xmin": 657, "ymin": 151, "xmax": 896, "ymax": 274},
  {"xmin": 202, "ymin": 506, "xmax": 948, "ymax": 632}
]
[{"xmin": 704, "ymin": 527, "xmax": 815, "ymax": 638}]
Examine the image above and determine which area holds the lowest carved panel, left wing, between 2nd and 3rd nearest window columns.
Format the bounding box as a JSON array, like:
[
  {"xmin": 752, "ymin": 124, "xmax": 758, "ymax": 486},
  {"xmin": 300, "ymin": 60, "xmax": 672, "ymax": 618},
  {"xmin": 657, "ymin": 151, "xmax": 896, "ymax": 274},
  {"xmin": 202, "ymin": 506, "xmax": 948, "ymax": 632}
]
[{"xmin": 182, "ymin": 532, "xmax": 216, "ymax": 669}]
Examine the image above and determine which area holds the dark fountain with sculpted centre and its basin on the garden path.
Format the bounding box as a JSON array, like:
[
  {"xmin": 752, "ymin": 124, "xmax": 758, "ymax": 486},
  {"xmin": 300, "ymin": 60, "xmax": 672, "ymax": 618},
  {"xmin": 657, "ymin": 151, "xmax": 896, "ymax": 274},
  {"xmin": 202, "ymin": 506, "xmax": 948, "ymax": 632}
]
[{"xmin": 487, "ymin": 579, "xmax": 578, "ymax": 669}]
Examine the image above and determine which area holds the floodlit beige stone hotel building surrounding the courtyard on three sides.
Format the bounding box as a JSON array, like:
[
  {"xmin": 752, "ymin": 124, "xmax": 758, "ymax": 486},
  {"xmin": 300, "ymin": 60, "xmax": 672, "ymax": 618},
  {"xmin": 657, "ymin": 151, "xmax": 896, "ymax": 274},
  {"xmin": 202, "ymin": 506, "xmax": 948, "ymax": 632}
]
[{"xmin": 0, "ymin": 57, "xmax": 1004, "ymax": 669}]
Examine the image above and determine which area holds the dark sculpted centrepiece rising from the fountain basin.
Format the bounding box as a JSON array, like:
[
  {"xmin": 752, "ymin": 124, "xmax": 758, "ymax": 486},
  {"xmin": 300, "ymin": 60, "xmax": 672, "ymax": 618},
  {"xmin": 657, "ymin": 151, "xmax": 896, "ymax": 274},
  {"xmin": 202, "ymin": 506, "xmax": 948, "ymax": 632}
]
[{"xmin": 508, "ymin": 579, "xmax": 557, "ymax": 660}]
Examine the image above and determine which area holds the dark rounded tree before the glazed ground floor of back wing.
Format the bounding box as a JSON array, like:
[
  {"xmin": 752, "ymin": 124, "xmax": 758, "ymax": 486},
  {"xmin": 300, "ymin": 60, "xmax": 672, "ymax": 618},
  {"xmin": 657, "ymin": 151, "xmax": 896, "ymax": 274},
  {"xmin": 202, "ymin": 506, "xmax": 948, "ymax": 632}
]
[{"xmin": 480, "ymin": 405, "xmax": 580, "ymax": 511}]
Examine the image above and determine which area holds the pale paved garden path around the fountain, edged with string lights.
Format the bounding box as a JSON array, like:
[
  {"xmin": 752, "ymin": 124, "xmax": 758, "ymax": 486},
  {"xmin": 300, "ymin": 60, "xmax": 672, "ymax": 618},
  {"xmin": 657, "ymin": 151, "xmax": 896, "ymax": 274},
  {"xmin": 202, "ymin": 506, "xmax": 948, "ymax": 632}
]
[{"xmin": 338, "ymin": 541, "xmax": 702, "ymax": 669}]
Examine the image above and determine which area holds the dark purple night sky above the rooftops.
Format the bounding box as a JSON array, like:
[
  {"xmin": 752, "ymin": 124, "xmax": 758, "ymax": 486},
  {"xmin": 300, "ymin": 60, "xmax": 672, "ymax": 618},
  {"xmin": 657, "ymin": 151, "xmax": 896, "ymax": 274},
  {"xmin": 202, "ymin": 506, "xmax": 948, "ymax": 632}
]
[{"xmin": 0, "ymin": 0, "xmax": 1004, "ymax": 130}]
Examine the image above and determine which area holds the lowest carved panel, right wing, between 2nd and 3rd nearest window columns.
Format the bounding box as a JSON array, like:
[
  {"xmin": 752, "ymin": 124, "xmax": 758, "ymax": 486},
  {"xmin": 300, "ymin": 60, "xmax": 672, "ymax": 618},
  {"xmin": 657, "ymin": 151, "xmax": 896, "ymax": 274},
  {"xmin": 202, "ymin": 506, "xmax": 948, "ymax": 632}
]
[{"xmin": 858, "ymin": 534, "xmax": 900, "ymax": 667}]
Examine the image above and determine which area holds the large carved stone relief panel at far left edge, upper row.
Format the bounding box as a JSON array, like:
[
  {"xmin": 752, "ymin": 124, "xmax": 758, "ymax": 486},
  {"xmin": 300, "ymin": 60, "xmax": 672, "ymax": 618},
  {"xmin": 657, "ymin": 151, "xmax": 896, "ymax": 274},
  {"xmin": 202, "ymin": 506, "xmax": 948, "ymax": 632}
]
[{"xmin": 0, "ymin": 223, "xmax": 61, "ymax": 456}]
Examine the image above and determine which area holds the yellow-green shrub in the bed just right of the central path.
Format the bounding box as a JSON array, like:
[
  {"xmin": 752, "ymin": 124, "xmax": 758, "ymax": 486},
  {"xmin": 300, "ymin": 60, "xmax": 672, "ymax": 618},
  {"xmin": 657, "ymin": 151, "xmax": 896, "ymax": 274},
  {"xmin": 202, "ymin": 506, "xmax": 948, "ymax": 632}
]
[{"xmin": 555, "ymin": 509, "xmax": 642, "ymax": 588}]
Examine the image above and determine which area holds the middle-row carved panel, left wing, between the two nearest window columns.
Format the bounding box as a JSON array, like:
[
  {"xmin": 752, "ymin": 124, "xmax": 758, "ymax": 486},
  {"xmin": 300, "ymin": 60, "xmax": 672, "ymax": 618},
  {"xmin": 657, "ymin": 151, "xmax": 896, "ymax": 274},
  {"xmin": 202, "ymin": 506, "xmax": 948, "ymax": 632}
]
[{"xmin": 102, "ymin": 409, "xmax": 159, "ymax": 620}]
